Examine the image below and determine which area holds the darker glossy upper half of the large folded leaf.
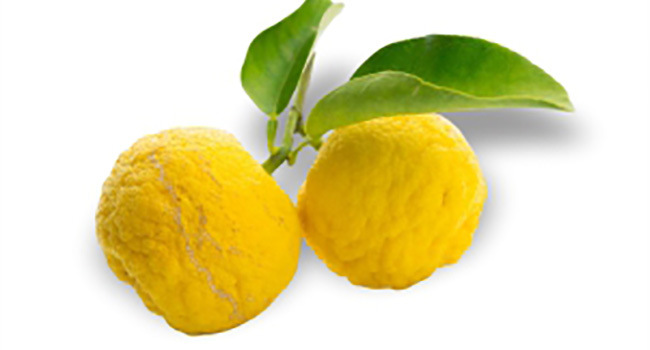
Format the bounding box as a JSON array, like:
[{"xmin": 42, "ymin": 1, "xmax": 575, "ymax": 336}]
[{"xmin": 353, "ymin": 35, "xmax": 572, "ymax": 110}]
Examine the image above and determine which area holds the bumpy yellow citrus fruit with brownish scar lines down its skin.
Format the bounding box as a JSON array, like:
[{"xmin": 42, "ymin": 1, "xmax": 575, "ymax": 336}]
[{"xmin": 96, "ymin": 128, "xmax": 301, "ymax": 334}]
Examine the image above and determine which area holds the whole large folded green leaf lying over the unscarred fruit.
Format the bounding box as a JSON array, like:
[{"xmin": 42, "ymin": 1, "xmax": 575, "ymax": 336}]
[{"xmin": 306, "ymin": 35, "xmax": 573, "ymax": 139}]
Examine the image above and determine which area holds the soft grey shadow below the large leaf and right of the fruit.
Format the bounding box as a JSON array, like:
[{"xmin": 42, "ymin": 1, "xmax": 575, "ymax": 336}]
[{"xmin": 443, "ymin": 109, "xmax": 587, "ymax": 270}]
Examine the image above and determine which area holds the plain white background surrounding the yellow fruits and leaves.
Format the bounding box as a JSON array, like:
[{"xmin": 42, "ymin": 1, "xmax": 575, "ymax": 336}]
[{"xmin": 0, "ymin": 0, "xmax": 650, "ymax": 350}]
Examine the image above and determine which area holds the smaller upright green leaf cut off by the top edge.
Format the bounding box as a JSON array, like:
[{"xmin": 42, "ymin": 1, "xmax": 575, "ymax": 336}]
[{"xmin": 241, "ymin": 0, "xmax": 343, "ymax": 117}]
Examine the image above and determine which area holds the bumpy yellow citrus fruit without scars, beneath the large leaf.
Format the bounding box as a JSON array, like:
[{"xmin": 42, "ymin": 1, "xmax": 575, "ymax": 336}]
[{"xmin": 298, "ymin": 115, "xmax": 487, "ymax": 289}]
